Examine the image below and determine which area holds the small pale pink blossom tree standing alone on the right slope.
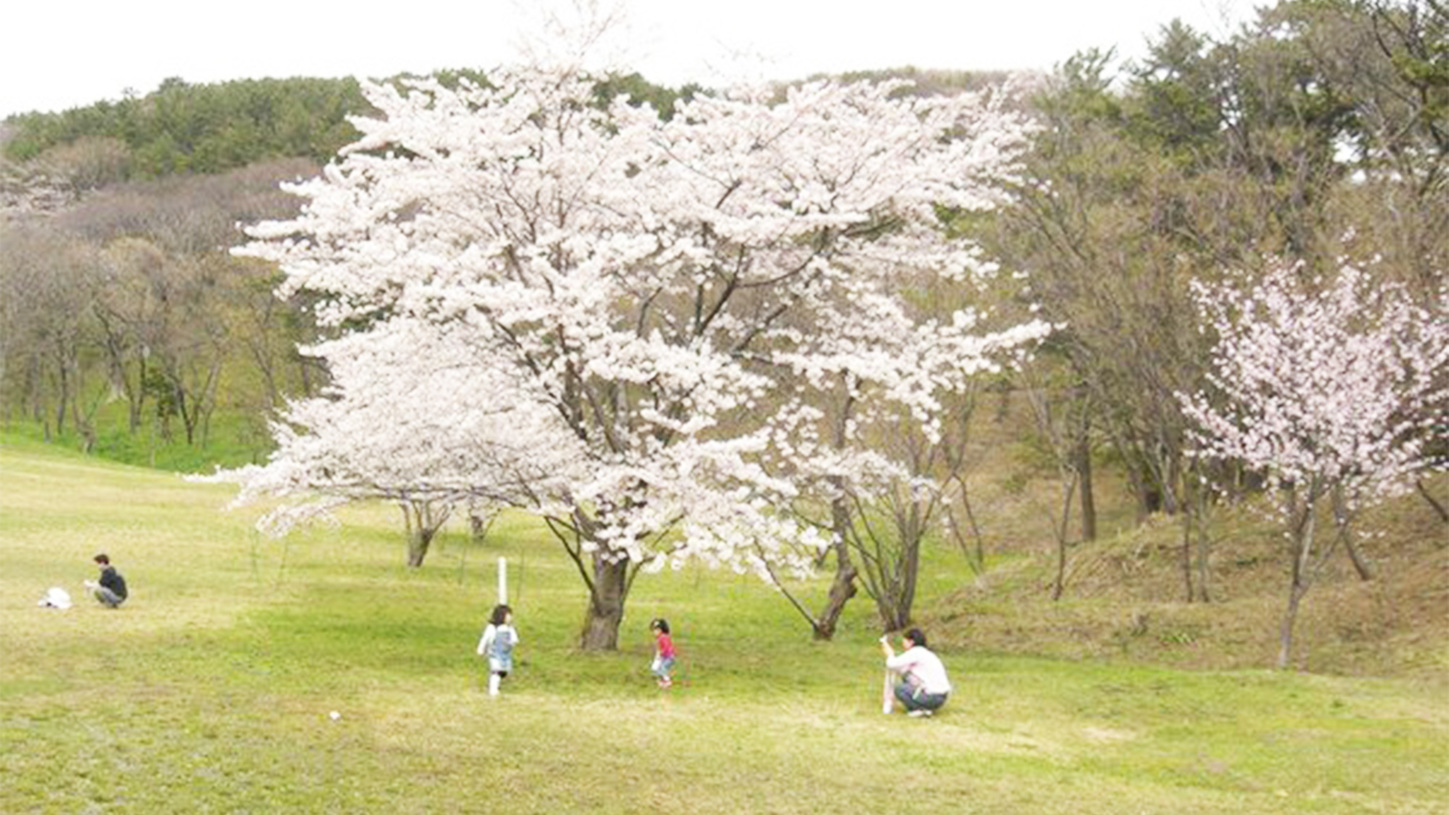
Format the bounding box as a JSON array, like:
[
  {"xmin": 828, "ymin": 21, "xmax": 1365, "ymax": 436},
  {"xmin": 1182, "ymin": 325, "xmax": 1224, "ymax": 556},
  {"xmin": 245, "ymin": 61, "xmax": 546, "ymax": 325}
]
[{"xmin": 1178, "ymin": 262, "xmax": 1449, "ymax": 667}]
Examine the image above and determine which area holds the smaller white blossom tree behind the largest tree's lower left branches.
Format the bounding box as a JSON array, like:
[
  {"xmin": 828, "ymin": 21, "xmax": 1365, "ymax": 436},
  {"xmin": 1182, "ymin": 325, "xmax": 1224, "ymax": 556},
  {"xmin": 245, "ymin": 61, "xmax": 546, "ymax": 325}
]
[{"xmin": 204, "ymin": 319, "xmax": 558, "ymax": 567}]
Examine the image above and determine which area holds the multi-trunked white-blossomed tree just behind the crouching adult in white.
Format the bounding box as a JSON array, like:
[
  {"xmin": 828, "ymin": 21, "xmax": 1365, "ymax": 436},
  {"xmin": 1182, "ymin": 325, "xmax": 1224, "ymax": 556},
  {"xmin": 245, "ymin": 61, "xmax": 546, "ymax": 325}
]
[{"xmin": 771, "ymin": 301, "xmax": 1052, "ymax": 640}]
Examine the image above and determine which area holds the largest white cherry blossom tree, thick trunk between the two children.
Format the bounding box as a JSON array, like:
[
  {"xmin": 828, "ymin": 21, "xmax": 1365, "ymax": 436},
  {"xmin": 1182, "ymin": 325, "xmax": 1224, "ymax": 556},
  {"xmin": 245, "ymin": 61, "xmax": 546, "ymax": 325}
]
[{"xmin": 241, "ymin": 67, "xmax": 1049, "ymax": 650}]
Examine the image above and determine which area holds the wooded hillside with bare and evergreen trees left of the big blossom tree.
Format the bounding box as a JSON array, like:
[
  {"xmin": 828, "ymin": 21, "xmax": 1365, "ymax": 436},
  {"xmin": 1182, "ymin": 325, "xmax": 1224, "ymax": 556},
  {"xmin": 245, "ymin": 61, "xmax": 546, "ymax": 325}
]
[{"xmin": 0, "ymin": 70, "xmax": 697, "ymax": 470}]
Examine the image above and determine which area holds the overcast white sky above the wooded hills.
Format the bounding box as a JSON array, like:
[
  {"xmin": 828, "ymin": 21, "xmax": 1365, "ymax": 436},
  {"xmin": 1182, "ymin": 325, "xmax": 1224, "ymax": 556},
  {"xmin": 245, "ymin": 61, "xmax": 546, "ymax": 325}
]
[{"xmin": 0, "ymin": 0, "xmax": 1268, "ymax": 117}]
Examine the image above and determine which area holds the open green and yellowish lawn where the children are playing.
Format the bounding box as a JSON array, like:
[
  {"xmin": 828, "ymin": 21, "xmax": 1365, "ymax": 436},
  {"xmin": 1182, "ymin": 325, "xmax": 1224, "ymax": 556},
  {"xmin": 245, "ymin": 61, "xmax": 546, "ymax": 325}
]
[{"xmin": 0, "ymin": 444, "xmax": 1449, "ymax": 814}]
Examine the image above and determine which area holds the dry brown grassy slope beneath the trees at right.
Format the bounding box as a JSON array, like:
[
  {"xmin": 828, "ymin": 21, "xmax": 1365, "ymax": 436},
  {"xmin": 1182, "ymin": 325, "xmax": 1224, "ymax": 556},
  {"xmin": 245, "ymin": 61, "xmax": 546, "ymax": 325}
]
[{"xmin": 926, "ymin": 474, "xmax": 1449, "ymax": 672}]
